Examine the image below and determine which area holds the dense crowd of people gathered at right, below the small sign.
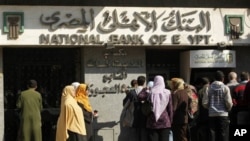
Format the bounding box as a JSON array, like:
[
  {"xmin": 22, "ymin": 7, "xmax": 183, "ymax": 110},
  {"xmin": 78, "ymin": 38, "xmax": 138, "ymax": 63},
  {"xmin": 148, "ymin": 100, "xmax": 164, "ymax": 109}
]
[{"xmin": 122, "ymin": 70, "xmax": 250, "ymax": 141}]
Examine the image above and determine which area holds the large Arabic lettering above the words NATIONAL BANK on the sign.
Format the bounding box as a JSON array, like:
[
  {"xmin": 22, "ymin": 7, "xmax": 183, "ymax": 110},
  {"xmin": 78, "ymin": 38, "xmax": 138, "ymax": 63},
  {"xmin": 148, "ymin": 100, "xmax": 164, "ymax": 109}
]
[{"xmin": 40, "ymin": 8, "xmax": 211, "ymax": 34}]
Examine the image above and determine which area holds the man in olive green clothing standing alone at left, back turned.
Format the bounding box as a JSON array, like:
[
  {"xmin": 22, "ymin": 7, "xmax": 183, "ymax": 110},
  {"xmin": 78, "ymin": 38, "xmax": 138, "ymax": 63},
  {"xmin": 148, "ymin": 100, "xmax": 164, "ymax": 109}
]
[{"xmin": 16, "ymin": 80, "xmax": 42, "ymax": 141}]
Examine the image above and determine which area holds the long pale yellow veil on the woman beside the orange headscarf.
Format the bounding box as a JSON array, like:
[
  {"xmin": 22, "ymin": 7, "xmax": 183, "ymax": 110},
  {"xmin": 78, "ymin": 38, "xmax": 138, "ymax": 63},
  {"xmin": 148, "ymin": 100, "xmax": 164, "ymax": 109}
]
[{"xmin": 56, "ymin": 85, "xmax": 86, "ymax": 141}]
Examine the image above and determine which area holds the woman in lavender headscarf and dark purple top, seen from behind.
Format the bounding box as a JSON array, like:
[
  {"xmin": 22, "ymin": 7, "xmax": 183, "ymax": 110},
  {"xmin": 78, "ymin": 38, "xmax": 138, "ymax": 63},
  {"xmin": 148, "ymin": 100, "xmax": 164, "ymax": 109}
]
[{"xmin": 142, "ymin": 75, "xmax": 173, "ymax": 141}]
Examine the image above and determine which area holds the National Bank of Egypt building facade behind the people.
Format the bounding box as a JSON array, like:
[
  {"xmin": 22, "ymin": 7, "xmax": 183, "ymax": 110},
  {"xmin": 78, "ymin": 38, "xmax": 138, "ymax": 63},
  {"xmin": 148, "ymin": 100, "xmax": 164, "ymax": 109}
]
[{"xmin": 0, "ymin": 5, "xmax": 250, "ymax": 141}]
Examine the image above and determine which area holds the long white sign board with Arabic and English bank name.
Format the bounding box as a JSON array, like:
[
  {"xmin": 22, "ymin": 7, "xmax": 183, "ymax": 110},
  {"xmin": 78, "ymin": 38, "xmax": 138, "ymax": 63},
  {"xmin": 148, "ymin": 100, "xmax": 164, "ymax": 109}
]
[{"xmin": 0, "ymin": 6, "xmax": 250, "ymax": 46}]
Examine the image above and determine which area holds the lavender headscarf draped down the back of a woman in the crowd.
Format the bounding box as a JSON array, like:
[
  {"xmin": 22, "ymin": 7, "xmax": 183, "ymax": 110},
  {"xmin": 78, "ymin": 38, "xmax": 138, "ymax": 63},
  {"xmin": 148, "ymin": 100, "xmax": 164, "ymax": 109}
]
[{"xmin": 151, "ymin": 75, "xmax": 170, "ymax": 121}]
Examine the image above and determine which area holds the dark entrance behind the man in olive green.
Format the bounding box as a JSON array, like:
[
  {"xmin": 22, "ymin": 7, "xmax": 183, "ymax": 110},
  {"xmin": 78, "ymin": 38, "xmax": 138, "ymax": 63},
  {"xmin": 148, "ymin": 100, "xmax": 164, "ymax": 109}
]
[{"xmin": 3, "ymin": 48, "xmax": 80, "ymax": 141}]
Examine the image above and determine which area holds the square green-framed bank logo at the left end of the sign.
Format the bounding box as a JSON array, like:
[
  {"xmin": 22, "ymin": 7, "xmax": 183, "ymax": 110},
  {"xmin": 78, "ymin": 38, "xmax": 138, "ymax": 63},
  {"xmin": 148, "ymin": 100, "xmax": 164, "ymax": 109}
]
[{"xmin": 3, "ymin": 12, "xmax": 24, "ymax": 40}]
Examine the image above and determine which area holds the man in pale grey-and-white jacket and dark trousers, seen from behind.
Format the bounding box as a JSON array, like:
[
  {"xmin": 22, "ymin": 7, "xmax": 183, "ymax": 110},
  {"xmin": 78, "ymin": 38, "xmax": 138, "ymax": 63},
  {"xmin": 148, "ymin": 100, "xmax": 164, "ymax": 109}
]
[{"xmin": 202, "ymin": 71, "xmax": 233, "ymax": 141}]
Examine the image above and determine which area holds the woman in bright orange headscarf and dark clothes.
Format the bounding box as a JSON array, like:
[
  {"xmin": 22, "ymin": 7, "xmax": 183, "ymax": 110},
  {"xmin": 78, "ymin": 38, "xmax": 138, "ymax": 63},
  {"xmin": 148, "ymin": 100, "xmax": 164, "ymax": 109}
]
[{"xmin": 76, "ymin": 84, "xmax": 94, "ymax": 141}]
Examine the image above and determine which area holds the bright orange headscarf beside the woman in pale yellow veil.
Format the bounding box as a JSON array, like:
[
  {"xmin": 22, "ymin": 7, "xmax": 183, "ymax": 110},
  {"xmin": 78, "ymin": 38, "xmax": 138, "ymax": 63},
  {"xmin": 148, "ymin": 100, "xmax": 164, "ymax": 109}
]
[{"xmin": 76, "ymin": 84, "xmax": 92, "ymax": 112}]
